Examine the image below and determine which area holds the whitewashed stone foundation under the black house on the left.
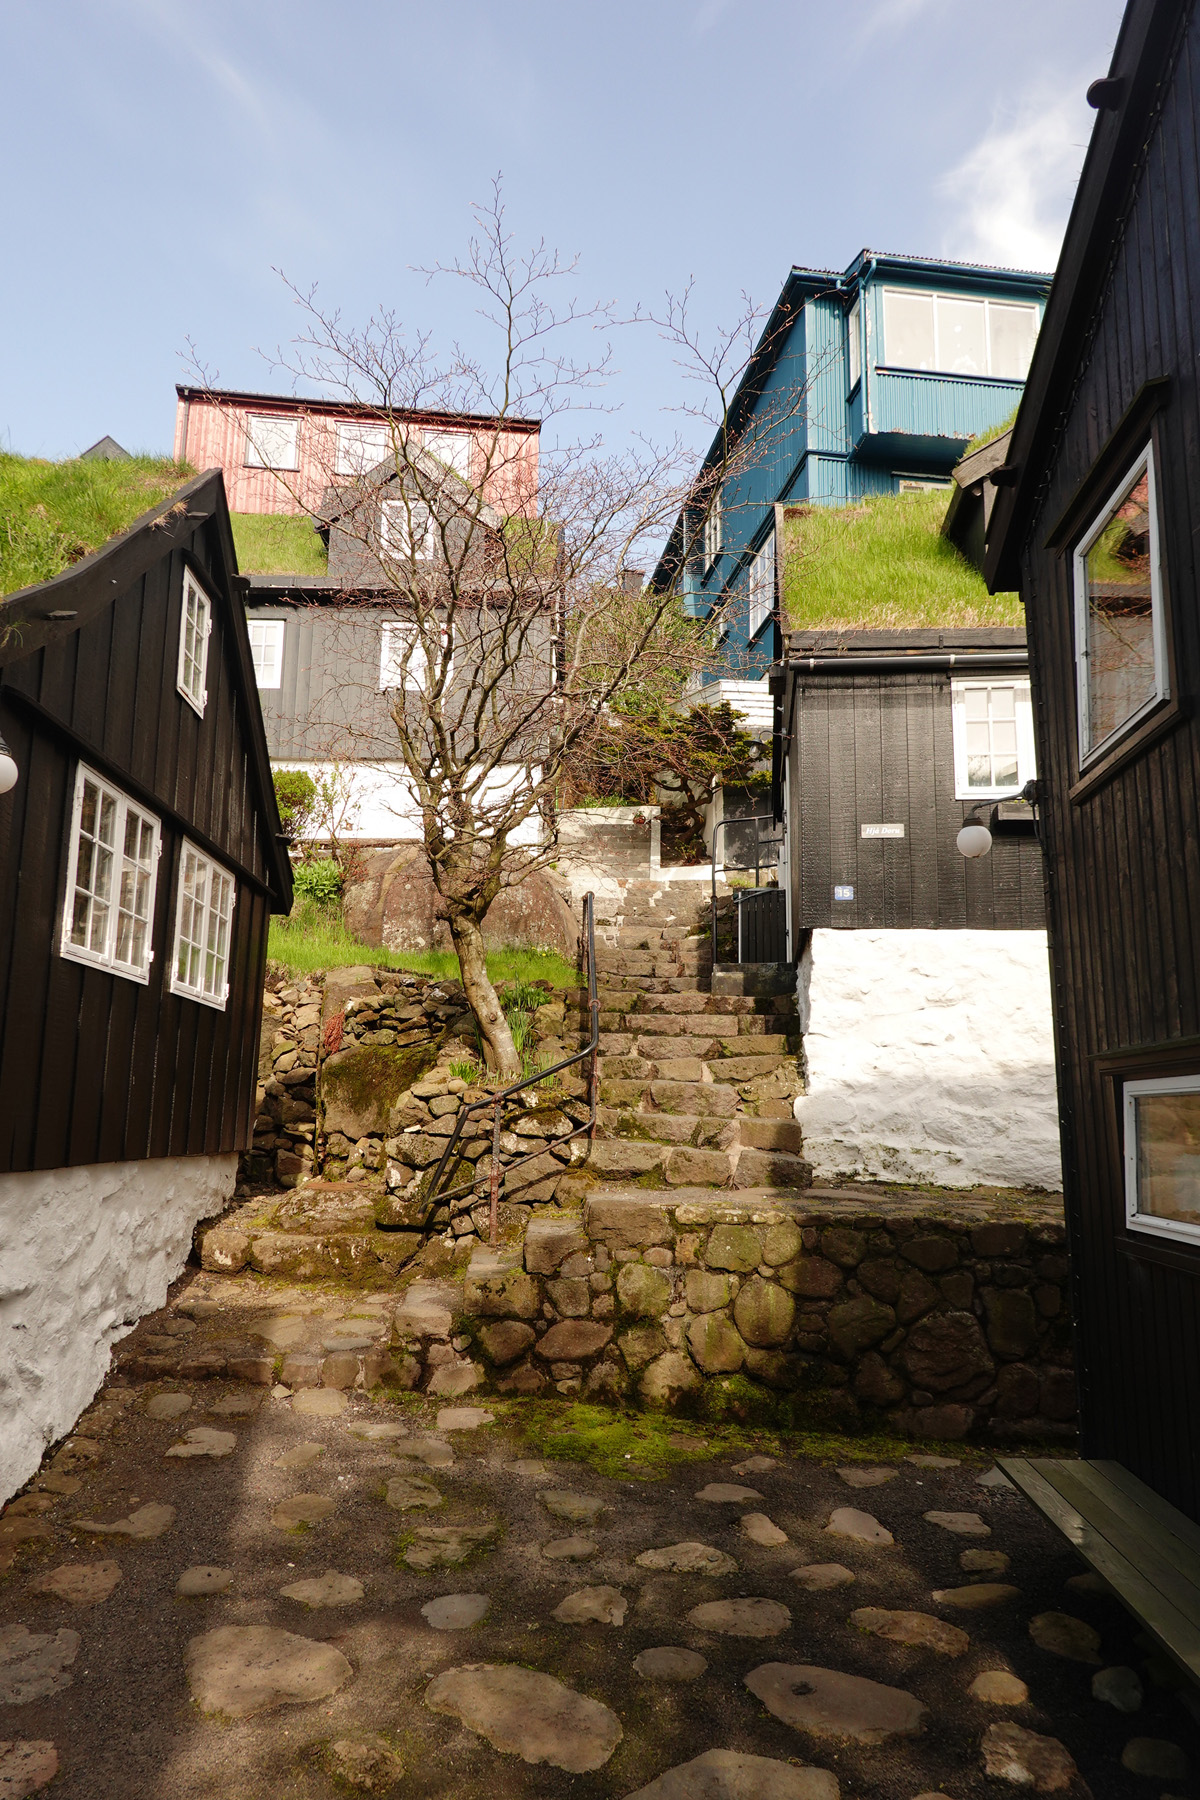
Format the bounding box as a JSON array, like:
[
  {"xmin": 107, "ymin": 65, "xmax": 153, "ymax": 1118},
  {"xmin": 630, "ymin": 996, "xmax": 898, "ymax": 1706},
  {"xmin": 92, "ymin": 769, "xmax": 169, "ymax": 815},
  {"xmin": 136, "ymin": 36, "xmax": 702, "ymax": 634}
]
[{"xmin": 0, "ymin": 1156, "xmax": 237, "ymax": 1501}]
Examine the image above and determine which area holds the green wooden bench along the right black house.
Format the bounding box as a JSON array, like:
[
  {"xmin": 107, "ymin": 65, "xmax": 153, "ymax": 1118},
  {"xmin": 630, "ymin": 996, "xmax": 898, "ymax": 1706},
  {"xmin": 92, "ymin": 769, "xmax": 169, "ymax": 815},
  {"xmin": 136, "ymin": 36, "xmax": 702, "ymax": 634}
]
[{"xmin": 1000, "ymin": 1456, "xmax": 1200, "ymax": 1681}]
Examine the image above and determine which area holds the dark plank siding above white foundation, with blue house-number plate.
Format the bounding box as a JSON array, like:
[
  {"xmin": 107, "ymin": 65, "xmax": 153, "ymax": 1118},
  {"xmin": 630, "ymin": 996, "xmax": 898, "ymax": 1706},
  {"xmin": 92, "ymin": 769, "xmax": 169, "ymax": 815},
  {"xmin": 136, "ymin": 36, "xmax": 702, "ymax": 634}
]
[{"xmin": 790, "ymin": 670, "xmax": 1045, "ymax": 931}]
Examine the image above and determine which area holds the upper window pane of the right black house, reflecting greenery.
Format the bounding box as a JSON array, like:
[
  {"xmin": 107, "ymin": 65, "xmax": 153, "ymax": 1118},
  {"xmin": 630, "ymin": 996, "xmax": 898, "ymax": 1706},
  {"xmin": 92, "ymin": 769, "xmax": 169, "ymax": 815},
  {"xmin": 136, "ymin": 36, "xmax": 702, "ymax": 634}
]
[{"xmin": 1083, "ymin": 470, "xmax": 1157, "ymax": 747}]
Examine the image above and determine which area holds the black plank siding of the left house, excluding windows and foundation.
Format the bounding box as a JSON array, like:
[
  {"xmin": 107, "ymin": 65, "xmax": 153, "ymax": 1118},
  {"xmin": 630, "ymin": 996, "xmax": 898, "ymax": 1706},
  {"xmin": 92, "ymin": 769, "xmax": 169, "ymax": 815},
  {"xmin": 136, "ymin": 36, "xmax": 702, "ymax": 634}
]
[{"xmin": 0, "ymin": 477, "xmax": 290, "ymax": 1172}]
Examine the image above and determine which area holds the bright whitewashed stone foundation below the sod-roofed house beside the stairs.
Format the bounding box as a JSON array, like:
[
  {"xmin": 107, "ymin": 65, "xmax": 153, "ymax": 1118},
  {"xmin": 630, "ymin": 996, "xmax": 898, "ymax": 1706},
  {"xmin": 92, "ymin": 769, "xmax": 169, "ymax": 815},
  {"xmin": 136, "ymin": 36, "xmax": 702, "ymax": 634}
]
[{"xmin": 795, "ymin": 929, "xmax": 1061, "ymax": 1190}]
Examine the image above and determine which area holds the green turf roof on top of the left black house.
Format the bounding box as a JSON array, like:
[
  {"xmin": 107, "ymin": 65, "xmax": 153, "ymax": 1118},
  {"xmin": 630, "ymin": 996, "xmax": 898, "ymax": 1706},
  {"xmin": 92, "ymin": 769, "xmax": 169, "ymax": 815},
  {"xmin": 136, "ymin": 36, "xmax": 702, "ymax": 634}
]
[{"xmin": 0, "ymin": 452, "xmax": 194, "ymax": 594}]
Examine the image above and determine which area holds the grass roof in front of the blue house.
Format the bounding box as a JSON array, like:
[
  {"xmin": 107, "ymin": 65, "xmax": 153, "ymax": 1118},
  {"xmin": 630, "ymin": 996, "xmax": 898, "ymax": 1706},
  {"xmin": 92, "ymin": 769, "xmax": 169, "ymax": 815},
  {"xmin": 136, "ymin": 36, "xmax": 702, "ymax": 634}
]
[{"xmin": 783, "ymin": 488, "xmax": 1025, "ymax": 632}]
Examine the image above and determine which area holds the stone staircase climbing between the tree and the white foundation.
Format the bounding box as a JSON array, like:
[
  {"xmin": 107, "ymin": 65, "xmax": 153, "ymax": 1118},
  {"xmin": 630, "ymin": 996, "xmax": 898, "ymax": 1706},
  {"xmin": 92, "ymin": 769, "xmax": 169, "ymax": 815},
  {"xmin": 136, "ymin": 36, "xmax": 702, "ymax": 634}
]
[{"xmin": 588, "ymin": 878, "xmax": 811, "ymax": 1192}]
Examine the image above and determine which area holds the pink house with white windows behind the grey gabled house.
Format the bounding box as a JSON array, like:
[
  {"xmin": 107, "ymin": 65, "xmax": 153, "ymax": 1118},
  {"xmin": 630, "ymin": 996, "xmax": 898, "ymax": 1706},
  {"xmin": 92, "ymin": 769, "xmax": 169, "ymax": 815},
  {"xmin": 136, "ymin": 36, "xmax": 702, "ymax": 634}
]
[{"xmin": 175, "ymin": 387, "xmax": 542, "ymax": 517}]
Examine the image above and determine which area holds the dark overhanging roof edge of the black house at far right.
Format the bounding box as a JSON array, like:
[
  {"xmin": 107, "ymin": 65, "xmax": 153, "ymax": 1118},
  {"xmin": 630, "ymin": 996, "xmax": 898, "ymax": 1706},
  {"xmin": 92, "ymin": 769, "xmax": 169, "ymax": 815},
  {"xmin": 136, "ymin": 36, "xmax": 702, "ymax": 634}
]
[{"xmin": 984, "ymin": 0, "xmax": 1186, "ymax": 590}]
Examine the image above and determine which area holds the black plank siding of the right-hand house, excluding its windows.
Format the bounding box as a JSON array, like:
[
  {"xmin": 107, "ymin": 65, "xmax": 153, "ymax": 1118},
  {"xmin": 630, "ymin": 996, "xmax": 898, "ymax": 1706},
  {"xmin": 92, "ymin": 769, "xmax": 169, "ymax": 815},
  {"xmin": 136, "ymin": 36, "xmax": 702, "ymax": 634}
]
[{"xmin": 1016, "ymin": 4, "xmax": 1200, "ymax": 1519}]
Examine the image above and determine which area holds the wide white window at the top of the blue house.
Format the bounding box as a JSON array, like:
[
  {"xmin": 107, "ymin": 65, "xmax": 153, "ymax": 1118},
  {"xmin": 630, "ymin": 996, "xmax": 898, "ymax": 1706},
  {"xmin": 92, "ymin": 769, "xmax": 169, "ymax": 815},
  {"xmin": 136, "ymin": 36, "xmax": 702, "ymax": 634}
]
[{"xmin": 883, "ymin": 288, "xmax": 1040, "ymax": 382}]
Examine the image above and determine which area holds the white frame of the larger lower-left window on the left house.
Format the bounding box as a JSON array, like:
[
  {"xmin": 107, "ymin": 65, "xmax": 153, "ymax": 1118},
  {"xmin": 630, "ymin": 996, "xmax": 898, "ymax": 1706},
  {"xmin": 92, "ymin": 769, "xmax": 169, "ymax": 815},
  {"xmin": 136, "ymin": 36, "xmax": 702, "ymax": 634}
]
[{"xmin": 58, "ymin": 763, "xmax": 162, "ymax": 986}]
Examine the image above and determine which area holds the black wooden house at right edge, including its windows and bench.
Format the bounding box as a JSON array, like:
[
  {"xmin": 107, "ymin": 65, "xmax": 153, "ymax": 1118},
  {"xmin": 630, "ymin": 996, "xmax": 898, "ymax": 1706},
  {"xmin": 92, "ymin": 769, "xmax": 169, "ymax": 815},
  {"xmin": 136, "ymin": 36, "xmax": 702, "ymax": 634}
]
[{"xmin": 986, "ymin": 0, "xmax": 1200, "ymax": 1674}]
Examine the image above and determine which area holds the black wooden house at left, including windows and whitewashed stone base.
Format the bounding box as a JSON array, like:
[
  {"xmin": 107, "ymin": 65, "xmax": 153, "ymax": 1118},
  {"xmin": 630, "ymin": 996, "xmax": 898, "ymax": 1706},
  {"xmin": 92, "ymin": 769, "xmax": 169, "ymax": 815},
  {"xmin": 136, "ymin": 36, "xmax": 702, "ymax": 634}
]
[{"xmin": 0, "ymin": 472, "xmax": 291, "ymax": 1496}]
